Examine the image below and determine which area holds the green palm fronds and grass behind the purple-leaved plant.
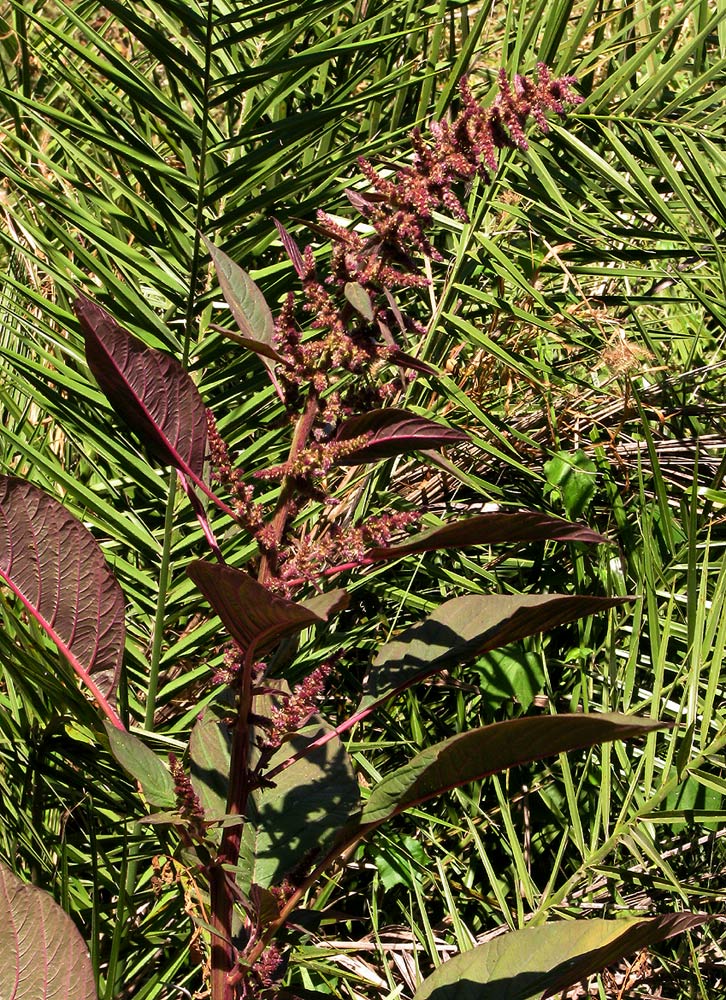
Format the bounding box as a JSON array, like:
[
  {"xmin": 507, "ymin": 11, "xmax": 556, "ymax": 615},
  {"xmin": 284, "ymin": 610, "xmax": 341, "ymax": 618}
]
[{"xmin": 0, "ymin": 0, "xmax": 726, "ymax": 1000}]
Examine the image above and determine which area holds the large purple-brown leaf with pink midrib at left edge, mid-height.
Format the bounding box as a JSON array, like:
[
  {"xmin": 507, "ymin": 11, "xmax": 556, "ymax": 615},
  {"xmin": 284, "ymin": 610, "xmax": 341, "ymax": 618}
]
[{"xmin": 0, "ymin": 476, "xmax": 126, "ymax": 729}]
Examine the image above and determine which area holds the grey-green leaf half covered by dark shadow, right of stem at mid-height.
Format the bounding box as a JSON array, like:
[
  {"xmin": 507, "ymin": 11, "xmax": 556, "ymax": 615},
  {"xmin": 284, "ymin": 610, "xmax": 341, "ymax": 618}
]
[{"xmin": 358, "ymin": 594, "xmax": 628, "ymax": 713}]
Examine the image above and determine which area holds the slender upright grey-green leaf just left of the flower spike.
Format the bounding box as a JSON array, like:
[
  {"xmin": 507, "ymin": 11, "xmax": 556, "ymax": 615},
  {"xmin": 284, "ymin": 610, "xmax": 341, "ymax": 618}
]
[{"xmin": 202, "ymin": 236, "xmax": 282, "ymax": 395}]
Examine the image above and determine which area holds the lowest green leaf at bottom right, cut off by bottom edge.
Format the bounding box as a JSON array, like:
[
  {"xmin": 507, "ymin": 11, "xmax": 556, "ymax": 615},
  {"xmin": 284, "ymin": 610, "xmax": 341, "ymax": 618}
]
[{"xmin": 414, "ymin": 913, "xmax": 708, "ymax": 1000}]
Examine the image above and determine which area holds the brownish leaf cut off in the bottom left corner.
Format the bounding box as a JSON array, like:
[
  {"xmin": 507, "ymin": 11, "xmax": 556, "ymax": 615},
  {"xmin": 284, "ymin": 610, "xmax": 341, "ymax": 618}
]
[{"xmin": 0, "ymin": 862, "xmax": 97, "ymax": 1000}]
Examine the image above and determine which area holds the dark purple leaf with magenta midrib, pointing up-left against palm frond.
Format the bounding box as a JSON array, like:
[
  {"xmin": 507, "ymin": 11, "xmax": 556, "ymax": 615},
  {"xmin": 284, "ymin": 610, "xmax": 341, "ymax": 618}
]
[{"xmin": 73, "ymin": 296, "xmax": 207, "ymax": 482}]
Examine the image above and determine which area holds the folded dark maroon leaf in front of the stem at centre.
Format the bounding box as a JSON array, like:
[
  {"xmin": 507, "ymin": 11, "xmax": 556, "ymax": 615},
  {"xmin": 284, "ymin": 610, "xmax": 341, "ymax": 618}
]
[{"xmin": 187, "ymin": 559, "xmax": 341, "ymax": 661}]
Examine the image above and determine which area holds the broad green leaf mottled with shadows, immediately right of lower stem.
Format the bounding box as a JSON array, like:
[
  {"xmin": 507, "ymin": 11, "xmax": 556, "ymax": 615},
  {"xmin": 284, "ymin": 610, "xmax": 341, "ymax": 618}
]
[{"xmin": 238, "ymin": 720, "xmax": 360, "ymax": 891}]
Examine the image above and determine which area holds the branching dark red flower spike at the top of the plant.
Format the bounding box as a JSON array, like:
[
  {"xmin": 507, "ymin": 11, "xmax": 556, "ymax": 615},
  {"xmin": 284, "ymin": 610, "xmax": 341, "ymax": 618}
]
[{"xmin": 209, "ymin": 63, "xmax": 582, "ymax": 596}]
